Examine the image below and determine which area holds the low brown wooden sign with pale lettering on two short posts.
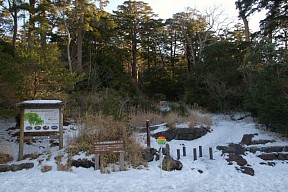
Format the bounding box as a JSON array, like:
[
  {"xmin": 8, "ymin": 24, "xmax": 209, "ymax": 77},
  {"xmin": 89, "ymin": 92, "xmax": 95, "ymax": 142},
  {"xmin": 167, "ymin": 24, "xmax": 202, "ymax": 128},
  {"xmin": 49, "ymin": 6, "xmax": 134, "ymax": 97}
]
[{"xmin": 94, "ymin": 140, "xmax": 125, "ymax": 171}]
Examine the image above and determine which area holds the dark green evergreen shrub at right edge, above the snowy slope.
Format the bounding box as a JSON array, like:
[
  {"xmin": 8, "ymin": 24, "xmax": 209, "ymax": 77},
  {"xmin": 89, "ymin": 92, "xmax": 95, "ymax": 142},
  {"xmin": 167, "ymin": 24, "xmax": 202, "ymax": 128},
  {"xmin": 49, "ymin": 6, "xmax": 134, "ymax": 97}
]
[{"xmin": 241, "ymin": 39, "xmax": 288, "ymax": 134}]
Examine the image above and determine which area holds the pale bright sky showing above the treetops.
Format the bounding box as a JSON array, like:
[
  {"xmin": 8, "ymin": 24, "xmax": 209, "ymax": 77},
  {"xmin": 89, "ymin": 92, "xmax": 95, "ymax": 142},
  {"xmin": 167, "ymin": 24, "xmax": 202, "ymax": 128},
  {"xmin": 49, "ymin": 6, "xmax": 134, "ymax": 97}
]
[{"xmin": 106, "ymin": 0, "xmax": 264, "ymax": 31}]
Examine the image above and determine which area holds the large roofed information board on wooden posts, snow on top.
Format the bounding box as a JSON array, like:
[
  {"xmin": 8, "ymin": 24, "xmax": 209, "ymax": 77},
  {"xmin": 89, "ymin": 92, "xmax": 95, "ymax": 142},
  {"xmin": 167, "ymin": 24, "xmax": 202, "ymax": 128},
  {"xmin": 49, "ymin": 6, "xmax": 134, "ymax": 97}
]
[{"xmin": 16, "ymin": 100, "xmax": 65, "ymax": 160}]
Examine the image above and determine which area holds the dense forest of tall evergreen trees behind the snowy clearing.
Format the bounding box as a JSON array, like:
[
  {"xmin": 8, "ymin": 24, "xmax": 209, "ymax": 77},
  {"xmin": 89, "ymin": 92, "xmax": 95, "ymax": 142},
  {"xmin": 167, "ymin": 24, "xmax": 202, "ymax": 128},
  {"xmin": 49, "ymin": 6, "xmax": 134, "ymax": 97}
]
[{"xmin": 0, "ymin": 0, "xmax": 288, "ymax": 134}]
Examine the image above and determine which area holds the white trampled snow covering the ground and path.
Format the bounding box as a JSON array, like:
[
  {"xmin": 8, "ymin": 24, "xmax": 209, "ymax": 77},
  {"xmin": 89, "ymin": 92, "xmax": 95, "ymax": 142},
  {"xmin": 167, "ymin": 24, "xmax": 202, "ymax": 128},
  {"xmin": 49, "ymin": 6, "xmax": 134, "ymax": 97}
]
[{"xmin": 0, "ymin": 115, "xmax": 288, "ymax": 192}]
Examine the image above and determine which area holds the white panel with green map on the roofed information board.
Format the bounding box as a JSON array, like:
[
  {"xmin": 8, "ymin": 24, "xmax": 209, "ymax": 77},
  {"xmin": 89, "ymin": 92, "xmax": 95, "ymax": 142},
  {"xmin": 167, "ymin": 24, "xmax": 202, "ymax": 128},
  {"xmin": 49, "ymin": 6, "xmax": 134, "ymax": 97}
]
[{"xmin": 24, "ymin": 109, "xmax": 59, "ymax": 132}]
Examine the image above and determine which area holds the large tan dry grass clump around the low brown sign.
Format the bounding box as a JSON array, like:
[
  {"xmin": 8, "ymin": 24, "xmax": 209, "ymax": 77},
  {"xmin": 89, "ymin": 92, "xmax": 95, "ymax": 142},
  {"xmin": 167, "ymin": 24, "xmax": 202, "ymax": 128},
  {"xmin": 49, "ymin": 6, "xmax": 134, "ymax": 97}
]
[{"xmin": 68, "ymin": 115, "xmax": 142, "ymax": 167}]
